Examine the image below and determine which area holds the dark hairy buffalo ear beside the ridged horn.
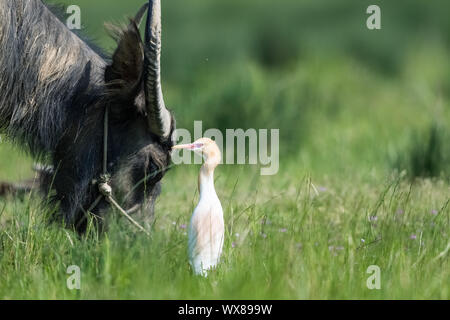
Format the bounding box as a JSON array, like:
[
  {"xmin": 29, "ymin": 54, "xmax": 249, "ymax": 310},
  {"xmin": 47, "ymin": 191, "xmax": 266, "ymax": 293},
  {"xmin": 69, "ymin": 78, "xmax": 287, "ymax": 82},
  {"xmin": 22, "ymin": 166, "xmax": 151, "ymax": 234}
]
[{"xmin": 105, "ymin": 20, "xmax": 144, "ymax": 93}]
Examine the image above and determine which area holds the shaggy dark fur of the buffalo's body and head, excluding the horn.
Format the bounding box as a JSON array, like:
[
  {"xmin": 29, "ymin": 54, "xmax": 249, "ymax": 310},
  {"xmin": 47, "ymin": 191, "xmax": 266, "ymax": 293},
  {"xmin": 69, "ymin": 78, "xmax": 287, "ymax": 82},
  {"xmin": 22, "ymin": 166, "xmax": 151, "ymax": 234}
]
[{"xmin": 0, "ymin": 0, "xmax": 175, "ymax": 231}]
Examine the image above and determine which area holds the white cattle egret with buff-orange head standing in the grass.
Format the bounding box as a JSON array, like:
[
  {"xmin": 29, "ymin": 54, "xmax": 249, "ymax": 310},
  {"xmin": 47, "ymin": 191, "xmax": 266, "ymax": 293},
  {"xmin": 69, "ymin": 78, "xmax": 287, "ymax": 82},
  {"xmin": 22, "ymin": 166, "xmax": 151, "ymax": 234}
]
[{"xmin": 173, "ymin": 138, "xmax": 224, "ymax": 276}]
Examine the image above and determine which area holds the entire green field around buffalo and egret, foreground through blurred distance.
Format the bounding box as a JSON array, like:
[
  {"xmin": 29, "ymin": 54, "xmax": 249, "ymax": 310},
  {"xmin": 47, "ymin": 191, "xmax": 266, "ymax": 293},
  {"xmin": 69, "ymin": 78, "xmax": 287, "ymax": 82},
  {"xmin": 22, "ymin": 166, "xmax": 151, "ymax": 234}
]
[{"xmin": 0, "ymin": 0, "xmax": 450, "ymax": 299}]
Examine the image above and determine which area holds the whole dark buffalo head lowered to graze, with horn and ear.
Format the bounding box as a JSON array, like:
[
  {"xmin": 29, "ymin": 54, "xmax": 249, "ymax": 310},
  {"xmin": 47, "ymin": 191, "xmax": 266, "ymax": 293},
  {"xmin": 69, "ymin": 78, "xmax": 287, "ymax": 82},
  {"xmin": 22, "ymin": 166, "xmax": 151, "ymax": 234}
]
[{"xmin": 50, "ymin": 0, "xmax": 175, "ymax": 229}]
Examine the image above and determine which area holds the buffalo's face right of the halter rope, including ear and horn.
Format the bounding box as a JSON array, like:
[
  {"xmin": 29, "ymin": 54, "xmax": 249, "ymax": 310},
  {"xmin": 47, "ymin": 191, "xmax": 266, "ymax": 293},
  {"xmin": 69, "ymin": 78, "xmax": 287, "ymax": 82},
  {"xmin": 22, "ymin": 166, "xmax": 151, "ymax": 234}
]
[{"xmin": 105, "ymin": 0, "xmax": 175, "ymax": 214}]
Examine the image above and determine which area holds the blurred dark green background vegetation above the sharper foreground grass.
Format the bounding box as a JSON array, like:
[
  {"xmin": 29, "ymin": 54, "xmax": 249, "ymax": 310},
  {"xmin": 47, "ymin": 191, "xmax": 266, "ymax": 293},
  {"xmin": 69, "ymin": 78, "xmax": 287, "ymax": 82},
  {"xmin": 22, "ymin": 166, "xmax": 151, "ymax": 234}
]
[{"xmin": 0, "ymin": 0, "xmax": 450, "ymax": 179}]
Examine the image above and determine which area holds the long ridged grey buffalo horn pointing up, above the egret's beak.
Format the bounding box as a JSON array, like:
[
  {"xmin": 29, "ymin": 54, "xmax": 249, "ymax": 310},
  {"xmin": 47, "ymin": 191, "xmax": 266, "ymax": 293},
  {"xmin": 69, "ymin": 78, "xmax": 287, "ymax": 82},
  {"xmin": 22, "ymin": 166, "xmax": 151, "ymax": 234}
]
[{"xmin": 144, "ymin": 0, "xmax": 171, "ymax": 138}]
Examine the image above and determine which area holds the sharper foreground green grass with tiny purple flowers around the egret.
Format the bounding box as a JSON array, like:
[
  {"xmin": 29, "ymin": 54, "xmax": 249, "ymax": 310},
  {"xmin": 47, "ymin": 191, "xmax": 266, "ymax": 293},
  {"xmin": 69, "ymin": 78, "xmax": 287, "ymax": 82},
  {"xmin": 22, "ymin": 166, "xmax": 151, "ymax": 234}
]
[{"xmin": 0, "ymin": 168, "xmax": 450, "ymax": 299}]
